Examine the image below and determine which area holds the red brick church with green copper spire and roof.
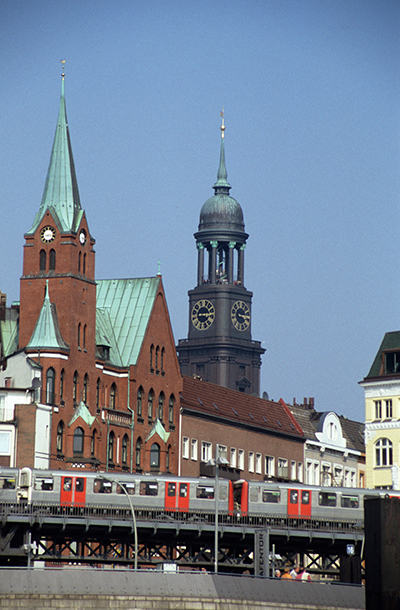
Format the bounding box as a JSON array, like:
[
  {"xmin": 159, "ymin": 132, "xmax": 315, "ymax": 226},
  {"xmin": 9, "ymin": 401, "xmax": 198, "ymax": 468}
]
[{"xmin": 0, "ymin": 70, "xmax": 182, "ymax": 473}]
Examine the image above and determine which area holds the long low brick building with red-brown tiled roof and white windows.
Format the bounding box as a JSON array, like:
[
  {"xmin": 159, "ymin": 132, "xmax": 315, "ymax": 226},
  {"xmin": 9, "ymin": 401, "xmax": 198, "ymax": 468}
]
[{"xmin": 179, "ymin": 376, "xmax": 305, "ymax": 481}]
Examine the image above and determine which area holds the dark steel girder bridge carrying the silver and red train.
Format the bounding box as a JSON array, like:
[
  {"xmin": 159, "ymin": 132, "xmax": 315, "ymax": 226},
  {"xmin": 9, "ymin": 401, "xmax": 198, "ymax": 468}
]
[{"xmin": 0, "ymin": 503, "xmax": 363, "ymax": 580}]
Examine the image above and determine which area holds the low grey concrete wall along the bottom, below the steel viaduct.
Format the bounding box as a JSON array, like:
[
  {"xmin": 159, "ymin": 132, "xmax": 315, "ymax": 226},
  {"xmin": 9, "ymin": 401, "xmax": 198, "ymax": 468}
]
[{"xmin": 0, "ymin": 568, "xmax": 365, "ymax": 610}]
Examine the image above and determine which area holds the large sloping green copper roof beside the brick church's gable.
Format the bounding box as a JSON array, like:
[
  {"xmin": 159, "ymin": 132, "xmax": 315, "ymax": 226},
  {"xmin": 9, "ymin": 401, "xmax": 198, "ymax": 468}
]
[{"xmin": 96, "ymin": 276, "xmax": 160, "ymax": 366}]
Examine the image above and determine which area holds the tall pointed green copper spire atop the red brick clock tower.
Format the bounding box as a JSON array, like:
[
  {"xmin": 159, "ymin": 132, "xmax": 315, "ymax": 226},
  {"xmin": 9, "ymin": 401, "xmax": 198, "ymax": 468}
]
[{"xmin": 27, "ymin": 75, "xmax": 83, "ymax": 235}]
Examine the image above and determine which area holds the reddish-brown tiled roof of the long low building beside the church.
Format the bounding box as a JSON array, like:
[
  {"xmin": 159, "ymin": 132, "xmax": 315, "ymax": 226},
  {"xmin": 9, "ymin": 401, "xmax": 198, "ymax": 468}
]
[{"xmin": 181, "ymin": 376, "xmax": 303, "ymax": 439}]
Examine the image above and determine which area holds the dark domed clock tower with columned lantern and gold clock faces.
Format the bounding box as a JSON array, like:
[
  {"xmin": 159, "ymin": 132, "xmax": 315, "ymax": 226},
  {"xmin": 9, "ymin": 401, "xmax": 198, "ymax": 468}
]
[{"xmin": 177, "ymin": 114, "xmax": 265, "ymax": 395}]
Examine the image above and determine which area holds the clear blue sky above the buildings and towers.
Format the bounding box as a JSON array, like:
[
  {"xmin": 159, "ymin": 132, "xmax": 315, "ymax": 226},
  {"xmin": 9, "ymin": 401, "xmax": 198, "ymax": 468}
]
[{"xmin": 0, "ymin": 0, "xmax": 400, "ymax": 420}]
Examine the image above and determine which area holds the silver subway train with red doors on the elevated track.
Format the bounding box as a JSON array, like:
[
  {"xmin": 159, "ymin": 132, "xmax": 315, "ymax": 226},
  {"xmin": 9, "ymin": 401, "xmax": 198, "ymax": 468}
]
[{"xmin": 0, "ymin": 468, "xmax": 400, "ymax": 527}]
